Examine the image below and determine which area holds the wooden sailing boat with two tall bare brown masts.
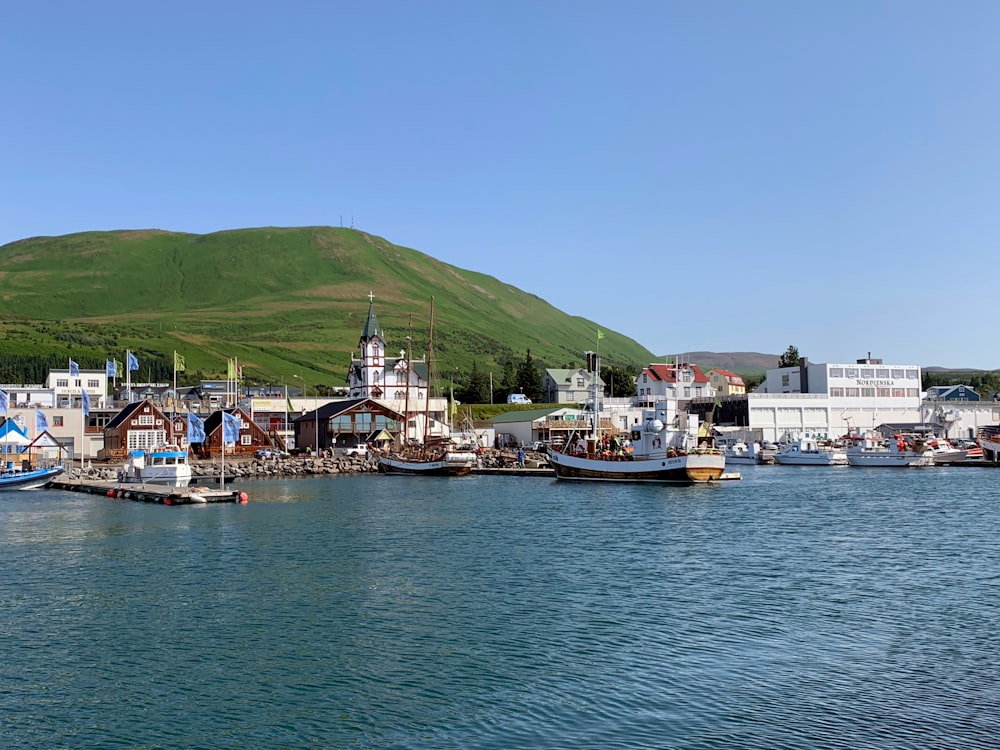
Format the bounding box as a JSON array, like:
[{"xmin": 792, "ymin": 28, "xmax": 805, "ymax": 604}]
[{"xmin": 379, "ymin": 297, "xmax": 476, "ymax": 476}]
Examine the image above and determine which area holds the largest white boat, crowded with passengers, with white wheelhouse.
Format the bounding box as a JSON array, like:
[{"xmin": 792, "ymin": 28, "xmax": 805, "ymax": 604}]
[{"xmin": 548, "ymin": 404, "xmax": 726, "ymax": 484}]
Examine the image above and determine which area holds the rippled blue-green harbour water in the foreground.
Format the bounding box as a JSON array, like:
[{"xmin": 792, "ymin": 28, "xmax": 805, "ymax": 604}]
[{"xmin": 0, "ymin": 466, "xmax": 1000, "ymax": 748}]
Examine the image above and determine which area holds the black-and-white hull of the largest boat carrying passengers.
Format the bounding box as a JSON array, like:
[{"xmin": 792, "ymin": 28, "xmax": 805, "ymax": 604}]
[{"xmin": 549, "ymin": 451, "xmax": 726, "ymax": 484}]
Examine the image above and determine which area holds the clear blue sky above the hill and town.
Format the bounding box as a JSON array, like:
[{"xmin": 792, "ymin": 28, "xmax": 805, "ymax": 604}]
[{"xmin": 0, "ymin": 0, "xmax": 1000, "ymax": 369}]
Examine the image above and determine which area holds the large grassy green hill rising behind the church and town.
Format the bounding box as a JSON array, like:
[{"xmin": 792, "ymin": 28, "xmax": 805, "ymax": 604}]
[{"xmin": 0, "ymin": 227, "xmax": 654, "ymax": 386}]
